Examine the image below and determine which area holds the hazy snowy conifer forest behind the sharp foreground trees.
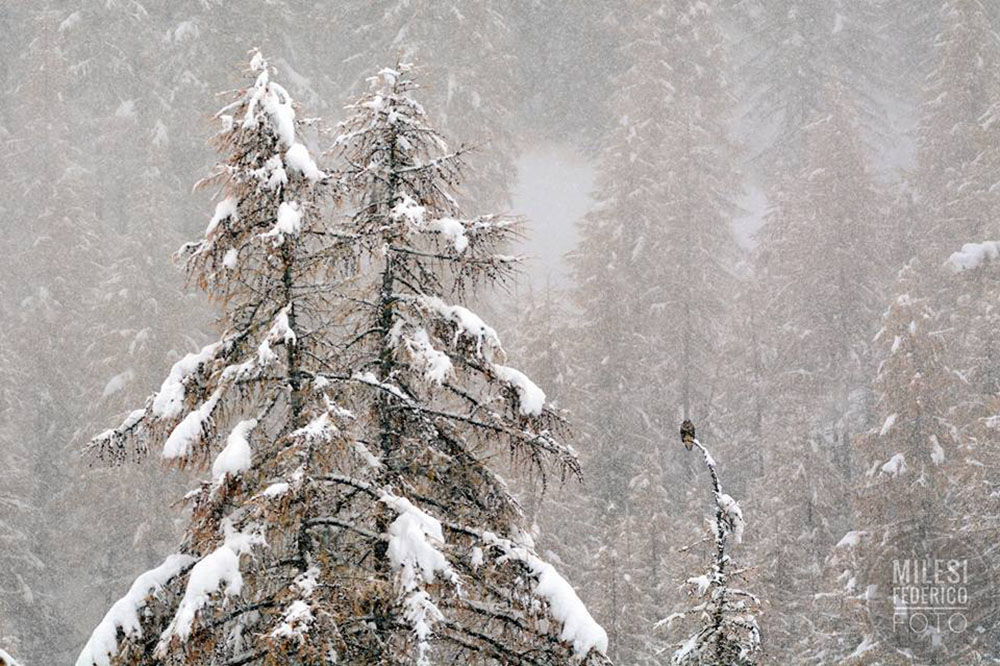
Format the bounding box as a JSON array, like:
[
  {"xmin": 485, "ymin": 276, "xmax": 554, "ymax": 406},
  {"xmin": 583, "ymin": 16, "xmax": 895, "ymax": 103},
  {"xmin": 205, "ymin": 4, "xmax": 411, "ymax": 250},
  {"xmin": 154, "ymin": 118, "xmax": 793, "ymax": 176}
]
[{"xmin": 0, "ymin": 0, "xmax": 1000, "ymax": 665}]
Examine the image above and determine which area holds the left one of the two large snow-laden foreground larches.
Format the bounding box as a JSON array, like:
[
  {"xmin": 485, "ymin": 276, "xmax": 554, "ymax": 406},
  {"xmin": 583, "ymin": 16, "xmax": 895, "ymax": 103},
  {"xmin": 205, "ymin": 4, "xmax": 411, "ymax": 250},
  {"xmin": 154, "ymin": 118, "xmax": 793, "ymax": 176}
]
[{"xmin": 77, "ymin": 53, "xmax": 335, "ymax": 666}]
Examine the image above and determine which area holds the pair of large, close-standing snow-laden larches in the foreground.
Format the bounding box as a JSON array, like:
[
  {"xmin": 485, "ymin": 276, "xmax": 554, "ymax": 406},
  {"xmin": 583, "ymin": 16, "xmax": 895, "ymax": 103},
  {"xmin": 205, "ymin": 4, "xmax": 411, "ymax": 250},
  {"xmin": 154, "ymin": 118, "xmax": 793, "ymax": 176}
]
[{"xmin": 78, "ymin": 54, "xmax": 607, "ymax": 666}]
